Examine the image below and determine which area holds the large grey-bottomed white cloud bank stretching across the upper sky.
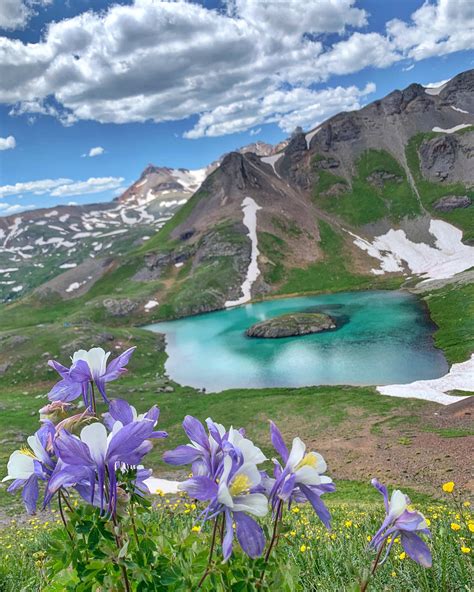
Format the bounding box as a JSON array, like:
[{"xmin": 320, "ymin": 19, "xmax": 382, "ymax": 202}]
[{"xmin": 0, "ymin": 0, "xmax": 474, "ymax": 138}]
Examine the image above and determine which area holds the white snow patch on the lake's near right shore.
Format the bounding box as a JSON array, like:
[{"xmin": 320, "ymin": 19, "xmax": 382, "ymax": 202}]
[{"xmin": 377, "ymin": 354, "xmax": 474, "ymax": 405}]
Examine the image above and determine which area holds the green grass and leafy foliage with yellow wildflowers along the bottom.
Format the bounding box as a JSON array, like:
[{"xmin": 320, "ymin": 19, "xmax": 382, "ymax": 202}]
[{"xmin": 0, "ymin": 497, "xmax": 474, "ymax": 592}]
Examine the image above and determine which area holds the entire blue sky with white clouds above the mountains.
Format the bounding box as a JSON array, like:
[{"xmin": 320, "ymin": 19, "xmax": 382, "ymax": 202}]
[{"xmin": 0, "ymin": 0, "xmax": 474, "ymax": 216}]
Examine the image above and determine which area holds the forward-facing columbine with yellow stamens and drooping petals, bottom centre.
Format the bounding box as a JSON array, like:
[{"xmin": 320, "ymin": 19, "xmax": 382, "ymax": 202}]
[{"xmin": 179, "ymin": 453, "xmax": 268, "ymax": 561}]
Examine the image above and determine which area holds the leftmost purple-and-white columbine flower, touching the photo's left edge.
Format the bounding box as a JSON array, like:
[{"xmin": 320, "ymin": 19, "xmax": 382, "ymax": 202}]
[{"xmin": 2, "ymin": 421, "xmax": 55, "ymax": 514}]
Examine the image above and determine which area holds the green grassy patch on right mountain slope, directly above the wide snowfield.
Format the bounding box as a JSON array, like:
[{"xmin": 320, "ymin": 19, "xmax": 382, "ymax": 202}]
[{"xmin": 314, "ymin": 150, "xmax": 420, "ymax": 226}]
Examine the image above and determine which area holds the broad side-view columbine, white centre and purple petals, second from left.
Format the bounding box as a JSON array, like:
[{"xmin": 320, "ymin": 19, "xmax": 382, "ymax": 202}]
[{"xmin": 48, "ymin": 420, "xmax": 154, "ymax": 513}]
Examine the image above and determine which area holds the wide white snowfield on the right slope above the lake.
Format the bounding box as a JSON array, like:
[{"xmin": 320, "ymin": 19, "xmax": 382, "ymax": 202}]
[{"xmin": 349, "ymin": 220, "xmax": 474, "ymax": 280}]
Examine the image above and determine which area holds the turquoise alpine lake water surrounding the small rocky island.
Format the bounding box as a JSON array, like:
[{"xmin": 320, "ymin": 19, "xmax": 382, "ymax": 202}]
[{"xmin": 146, "ymin": 291, "xmax": 448, "ymax": 392}]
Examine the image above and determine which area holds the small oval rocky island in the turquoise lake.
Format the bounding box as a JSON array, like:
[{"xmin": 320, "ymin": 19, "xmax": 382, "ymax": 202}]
[{"xmin": 245, "ymin": 312, "xmax": 336, "ymax": 339}]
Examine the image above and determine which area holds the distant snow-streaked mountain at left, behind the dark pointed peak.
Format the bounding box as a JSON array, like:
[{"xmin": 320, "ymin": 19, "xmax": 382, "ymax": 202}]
[{"xmin": 0, "ymin": 142, "xmax": 284, "ymax": 302}]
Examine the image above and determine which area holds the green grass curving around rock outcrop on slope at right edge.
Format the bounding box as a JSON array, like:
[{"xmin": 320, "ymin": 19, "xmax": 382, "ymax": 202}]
[{"xmin": 406, "ymin": 129, "xmax": 474, "ymax": 242}]
